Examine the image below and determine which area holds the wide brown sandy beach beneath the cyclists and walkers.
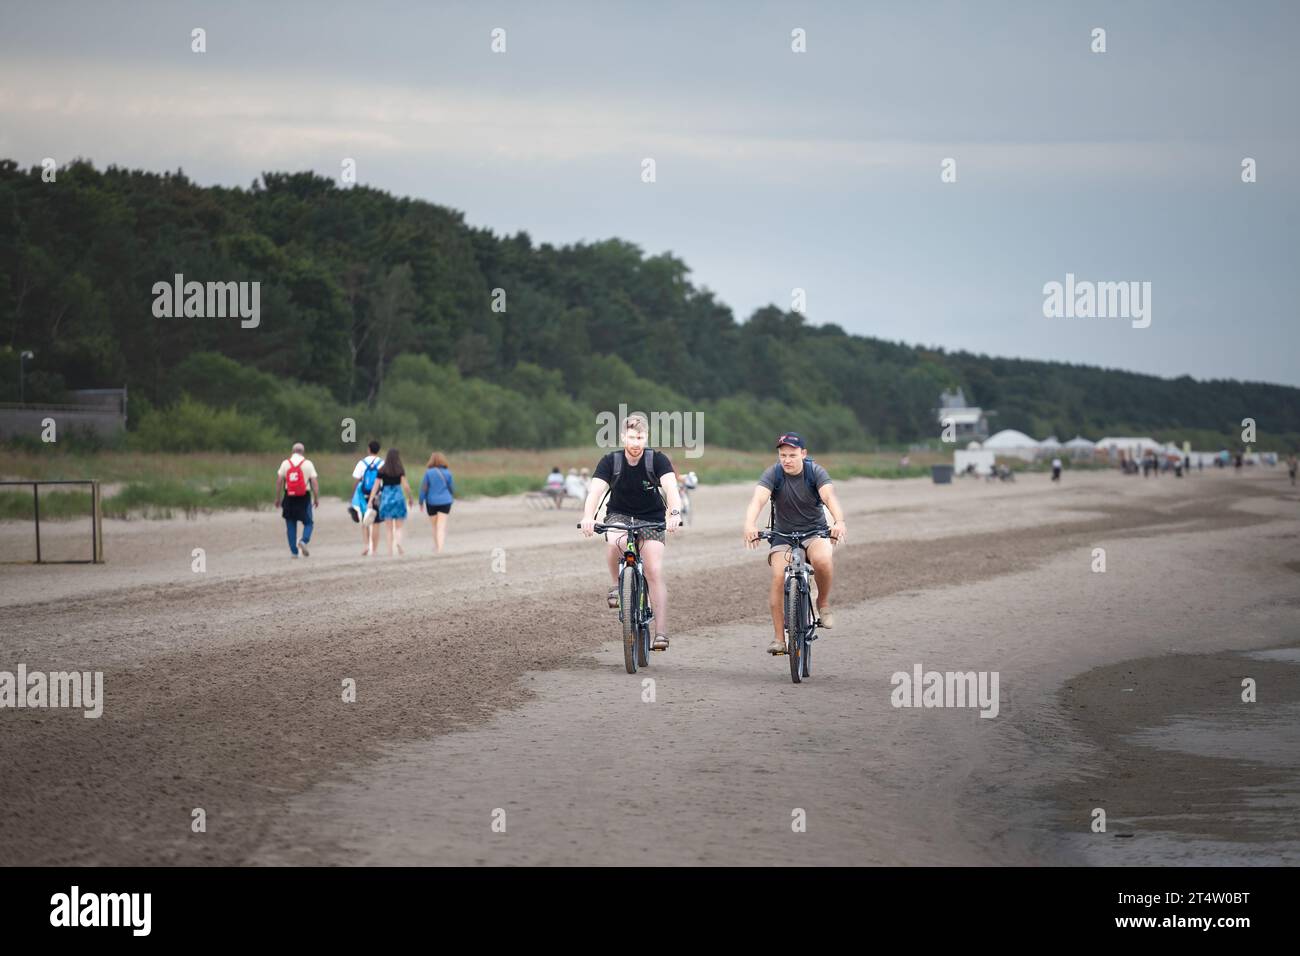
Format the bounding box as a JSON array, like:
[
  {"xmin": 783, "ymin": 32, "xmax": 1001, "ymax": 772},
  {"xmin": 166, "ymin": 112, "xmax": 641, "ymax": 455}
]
[{"xmin": 0, "ymin": 468, "xmax": 1300, "ymax": 865}]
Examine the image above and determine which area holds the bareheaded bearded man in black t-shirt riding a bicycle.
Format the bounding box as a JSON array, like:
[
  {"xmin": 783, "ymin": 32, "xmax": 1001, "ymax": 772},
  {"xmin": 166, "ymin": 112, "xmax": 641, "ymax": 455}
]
[{"xmin": 579, "ymin": 415, "xmax": 681, "ymax": 650}]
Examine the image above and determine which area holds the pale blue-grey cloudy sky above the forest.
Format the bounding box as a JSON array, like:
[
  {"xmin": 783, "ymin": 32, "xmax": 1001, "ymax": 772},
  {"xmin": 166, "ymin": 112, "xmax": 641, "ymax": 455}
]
[{"xmin": 0, "ymin": 0, "xmax": 1300, "ymax": 398}]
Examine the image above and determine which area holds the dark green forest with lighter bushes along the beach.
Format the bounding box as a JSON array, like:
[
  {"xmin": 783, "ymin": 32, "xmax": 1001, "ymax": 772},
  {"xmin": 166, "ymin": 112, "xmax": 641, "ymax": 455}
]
[{"xmin": 0, "ymin": 160, "xmax": 1300, "ymax": 451}]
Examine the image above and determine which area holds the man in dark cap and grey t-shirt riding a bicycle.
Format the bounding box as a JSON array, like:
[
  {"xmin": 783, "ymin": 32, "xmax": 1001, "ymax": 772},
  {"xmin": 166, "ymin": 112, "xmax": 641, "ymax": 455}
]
[{"xmin": 744, "ymin": 432, "xmax": 846, "ymax": 654}]
